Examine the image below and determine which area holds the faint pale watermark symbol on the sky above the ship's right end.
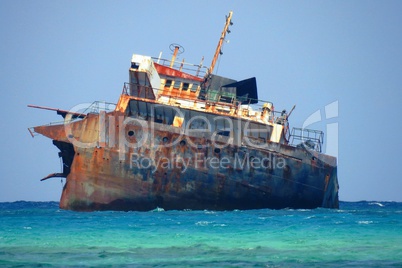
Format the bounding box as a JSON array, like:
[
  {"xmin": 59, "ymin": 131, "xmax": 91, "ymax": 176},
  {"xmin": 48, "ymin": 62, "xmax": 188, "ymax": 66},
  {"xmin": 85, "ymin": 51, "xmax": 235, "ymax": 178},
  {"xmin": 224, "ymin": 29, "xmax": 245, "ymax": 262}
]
[{"xmin": 302, "ymin": 101, "xmax": 339, "ymax": 165}]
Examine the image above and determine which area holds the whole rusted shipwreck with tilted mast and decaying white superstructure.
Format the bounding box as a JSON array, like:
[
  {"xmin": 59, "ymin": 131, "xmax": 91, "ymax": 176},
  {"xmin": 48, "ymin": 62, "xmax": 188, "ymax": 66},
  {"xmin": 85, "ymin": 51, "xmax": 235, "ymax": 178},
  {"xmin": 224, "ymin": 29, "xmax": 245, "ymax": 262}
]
[{"xmin": 29, "ymin": 12, "xmax": 339, "ymax": 211}]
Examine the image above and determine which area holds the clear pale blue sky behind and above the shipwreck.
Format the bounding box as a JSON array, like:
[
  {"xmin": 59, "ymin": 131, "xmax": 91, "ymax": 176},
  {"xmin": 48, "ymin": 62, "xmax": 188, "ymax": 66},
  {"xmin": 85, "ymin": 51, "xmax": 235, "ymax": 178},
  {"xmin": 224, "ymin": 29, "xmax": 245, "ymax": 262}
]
[{"xmin": 0, "ymin": 0, "xmax": 402, "ymax": 202}]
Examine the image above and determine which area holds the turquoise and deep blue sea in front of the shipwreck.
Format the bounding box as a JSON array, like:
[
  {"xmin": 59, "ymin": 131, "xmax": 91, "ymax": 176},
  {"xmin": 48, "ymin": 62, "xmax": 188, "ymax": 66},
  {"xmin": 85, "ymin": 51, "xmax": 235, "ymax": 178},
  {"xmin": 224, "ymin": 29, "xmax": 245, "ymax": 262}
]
[{"xmin": 0, "ymin": 202, "xmax": 402, "ymax": 267}]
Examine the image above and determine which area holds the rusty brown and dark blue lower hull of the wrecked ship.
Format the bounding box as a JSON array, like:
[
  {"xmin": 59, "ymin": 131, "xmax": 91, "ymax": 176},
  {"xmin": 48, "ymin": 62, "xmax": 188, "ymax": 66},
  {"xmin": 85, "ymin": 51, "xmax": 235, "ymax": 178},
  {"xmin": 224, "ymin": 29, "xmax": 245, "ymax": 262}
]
[{"xmin": 35, "ymin": 105, "xmax": 339, "ymax": 211}]
